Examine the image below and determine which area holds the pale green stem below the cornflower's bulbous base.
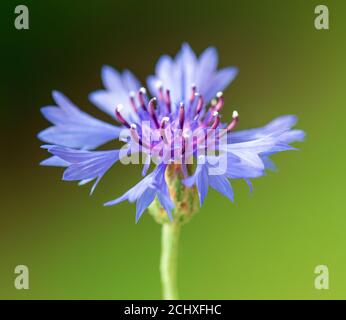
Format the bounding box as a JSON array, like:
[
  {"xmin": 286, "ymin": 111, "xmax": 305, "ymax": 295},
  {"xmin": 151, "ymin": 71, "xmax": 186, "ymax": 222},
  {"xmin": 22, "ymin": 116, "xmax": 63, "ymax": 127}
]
[{"xmin": 160, "ymin": 222, "xmax": 180, "ymax": 300}]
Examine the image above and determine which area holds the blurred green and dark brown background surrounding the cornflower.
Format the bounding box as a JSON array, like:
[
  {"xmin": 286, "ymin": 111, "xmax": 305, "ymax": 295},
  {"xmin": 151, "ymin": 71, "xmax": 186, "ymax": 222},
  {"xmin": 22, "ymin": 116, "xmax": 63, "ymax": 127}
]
[{"xmin": 0, "ymin": 0, "xmax": 346, "ymax": 299}]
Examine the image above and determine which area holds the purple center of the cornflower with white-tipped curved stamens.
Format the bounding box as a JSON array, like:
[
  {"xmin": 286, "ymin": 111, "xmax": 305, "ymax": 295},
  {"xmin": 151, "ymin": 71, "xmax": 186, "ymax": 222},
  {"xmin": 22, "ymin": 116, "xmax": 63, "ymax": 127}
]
[{"xmin": 115, "ymin": 85, "xmax": 239, "ymax": 163}]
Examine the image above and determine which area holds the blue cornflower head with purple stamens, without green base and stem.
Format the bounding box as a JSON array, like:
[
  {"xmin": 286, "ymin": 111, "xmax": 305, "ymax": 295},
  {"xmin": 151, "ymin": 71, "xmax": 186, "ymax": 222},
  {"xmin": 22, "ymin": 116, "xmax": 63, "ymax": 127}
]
[{"xmin": 38, "ymin": 44, "xmax": 304, "ymax": 221}]
